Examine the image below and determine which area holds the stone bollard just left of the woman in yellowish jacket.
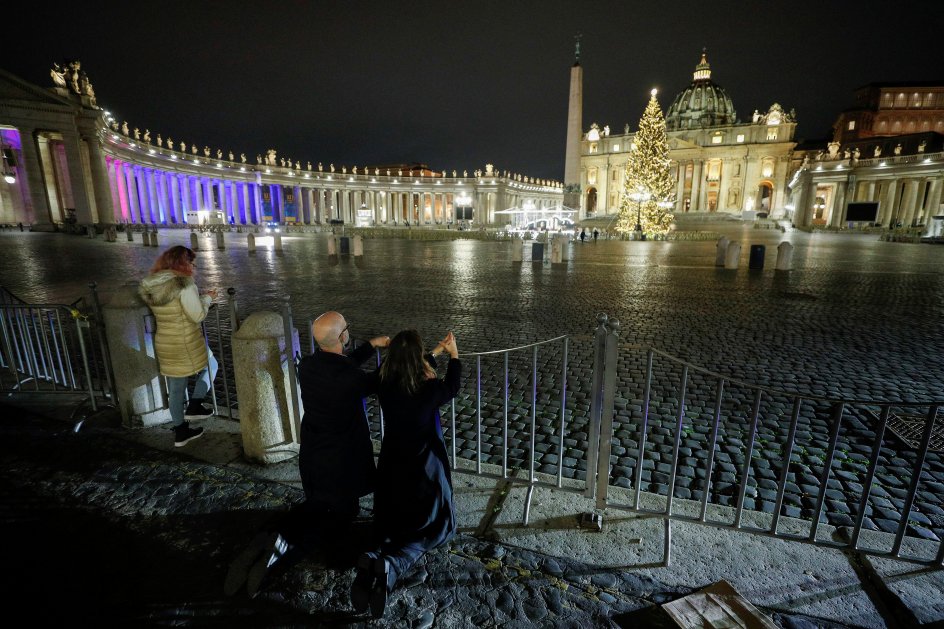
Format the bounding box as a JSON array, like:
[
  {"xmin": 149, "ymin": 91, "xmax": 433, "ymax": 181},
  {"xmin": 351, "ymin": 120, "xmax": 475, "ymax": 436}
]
[{"xmin": 102, "ymin": 284, "xmax": 171, "ymax": 428}]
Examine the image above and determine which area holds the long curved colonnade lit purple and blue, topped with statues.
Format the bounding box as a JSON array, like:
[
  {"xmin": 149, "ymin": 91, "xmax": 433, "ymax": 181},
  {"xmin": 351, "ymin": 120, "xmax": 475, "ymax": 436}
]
[{"xmin": 0, "ymin": 63, "xmax": 563, "ymax": 230}]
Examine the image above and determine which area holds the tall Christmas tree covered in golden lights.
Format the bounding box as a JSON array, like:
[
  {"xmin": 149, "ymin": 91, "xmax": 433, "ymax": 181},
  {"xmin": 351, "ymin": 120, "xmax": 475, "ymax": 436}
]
[{"xmin": 616, "ymin": 90, "xmax": 675, "ymax": 237}]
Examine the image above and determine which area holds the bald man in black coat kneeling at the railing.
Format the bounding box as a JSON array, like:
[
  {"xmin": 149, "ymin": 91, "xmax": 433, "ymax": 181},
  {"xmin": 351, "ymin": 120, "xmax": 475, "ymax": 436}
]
[{"xmin": 224, "ymin": 311, "xmax": 390, "ymax": 596}]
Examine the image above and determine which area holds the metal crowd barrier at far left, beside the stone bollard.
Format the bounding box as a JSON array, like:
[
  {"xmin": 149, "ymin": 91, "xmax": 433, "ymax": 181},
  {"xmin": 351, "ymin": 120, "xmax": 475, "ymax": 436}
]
[{"xmin": 0, "ymin": 285, "xmax": 113, "ymax": 412}]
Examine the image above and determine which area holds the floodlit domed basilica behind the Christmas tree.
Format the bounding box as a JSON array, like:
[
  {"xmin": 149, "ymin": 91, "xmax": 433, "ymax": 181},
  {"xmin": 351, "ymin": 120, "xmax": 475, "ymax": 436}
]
[{"xmin": 580, "ymin": 54, "xmax": 796, "ymax": 217}]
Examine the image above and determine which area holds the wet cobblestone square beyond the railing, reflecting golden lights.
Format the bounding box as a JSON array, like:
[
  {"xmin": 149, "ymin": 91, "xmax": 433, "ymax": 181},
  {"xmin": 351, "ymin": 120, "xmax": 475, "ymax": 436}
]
[{"xmin": 0, "ymin": 223, "xmax": 944, "ymax": 556}]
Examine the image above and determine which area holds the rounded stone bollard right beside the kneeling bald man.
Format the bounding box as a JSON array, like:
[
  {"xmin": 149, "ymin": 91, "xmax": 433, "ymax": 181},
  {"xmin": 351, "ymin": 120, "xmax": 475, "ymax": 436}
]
[{"xmin": 233, "ymin": 311, "xmax": 303, "ymax": 463}]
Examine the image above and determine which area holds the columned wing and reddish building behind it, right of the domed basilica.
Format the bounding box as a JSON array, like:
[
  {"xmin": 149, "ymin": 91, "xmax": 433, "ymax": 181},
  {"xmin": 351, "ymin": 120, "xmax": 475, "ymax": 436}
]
[{"xmin": 791, "ymin": 81, "xmax": 944, "ymax": 232}]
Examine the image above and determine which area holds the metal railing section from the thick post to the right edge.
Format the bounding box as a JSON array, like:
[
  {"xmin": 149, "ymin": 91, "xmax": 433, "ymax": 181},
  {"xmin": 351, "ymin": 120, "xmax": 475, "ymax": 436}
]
[{"xmin": 589, "ymin": 322, "xmax": 944, "ymax": 567}]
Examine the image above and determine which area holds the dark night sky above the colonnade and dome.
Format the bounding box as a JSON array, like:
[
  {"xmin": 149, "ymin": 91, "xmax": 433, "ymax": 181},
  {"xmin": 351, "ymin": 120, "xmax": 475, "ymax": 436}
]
[{"xmin": 7, "ymin": 0, "xmax": 944, "ymax": 180}]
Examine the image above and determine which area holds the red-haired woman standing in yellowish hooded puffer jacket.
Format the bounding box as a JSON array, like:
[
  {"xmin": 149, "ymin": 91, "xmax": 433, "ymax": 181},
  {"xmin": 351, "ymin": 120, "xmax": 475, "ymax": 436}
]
[{"xmin": 138, "ymin": 245, "xmax": 217, "ymax": 447}]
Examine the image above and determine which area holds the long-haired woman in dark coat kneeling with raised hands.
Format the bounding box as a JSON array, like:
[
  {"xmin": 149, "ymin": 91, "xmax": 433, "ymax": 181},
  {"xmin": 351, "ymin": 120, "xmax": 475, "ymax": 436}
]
[{"xmin": 351, "ymin": 330, "xmax": 462, "ymax": 618}]
